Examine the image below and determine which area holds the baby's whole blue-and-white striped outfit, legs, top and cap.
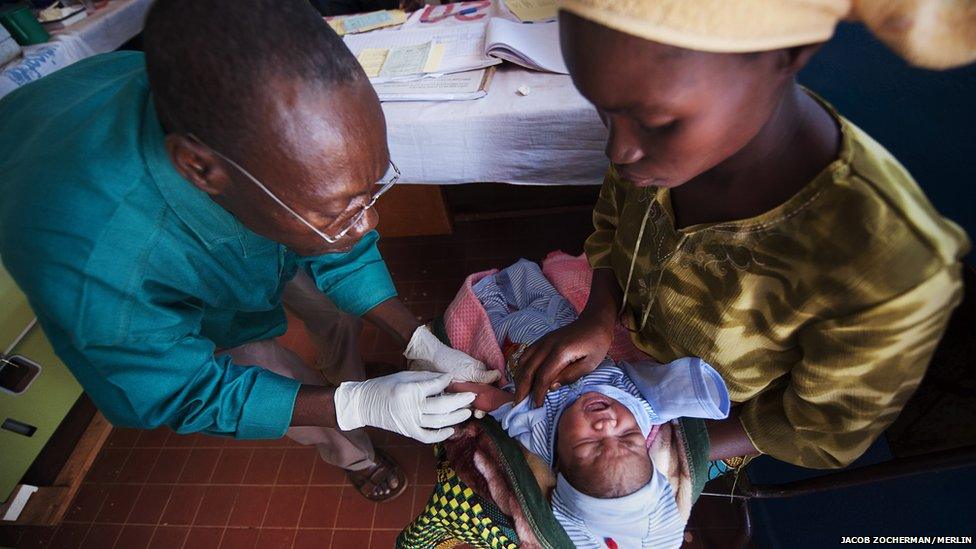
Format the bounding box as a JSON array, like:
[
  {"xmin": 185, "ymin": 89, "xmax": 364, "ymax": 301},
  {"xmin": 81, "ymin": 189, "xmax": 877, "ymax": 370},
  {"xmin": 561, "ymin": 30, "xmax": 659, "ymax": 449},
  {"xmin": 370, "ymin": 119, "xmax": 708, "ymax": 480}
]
[{"xmin": 473, "ymin": 260, "xmax": 729, "ymax": 548}]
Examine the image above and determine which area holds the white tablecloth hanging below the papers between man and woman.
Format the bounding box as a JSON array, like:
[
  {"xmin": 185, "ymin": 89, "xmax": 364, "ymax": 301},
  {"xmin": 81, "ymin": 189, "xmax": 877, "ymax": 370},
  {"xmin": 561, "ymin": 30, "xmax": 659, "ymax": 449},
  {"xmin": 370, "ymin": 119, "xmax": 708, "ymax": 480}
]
[{"xmin": 383, "ymin": 64, "xmax": 608, "ymax": 185}]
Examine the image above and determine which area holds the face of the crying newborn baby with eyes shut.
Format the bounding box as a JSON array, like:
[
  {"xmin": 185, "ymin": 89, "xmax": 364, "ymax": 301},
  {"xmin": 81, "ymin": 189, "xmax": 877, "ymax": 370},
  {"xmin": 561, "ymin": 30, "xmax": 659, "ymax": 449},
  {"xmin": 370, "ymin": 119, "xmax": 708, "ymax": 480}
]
[{"xmin": 556, "ymin": 392, "xmax": 652, "ymax": 498}]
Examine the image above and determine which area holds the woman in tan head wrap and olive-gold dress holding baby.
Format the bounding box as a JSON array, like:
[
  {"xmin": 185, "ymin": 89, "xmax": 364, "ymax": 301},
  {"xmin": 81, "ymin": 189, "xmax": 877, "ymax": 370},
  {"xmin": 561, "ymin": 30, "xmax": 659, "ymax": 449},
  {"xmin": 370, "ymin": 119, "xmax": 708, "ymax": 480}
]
[{"xmin": 516, "ymin": 0, "xmax": 976, "ymax": 468}]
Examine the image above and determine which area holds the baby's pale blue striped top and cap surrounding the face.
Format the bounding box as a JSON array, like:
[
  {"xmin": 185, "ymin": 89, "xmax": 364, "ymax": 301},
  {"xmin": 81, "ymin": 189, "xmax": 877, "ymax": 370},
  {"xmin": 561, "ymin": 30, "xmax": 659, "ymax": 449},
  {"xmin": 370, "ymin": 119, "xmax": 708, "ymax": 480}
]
[{"xmin": 492, "ymin": 358, "xmax": 729, "ymax": 548}]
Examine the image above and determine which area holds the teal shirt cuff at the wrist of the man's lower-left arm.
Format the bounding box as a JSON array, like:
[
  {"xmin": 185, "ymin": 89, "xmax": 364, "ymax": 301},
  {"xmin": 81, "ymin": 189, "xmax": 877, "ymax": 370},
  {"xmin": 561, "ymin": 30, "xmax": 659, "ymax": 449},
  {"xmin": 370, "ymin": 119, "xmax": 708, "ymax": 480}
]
[{"xmin": 237, "ymin": 370, "xmax": 301, "ymax": 439}]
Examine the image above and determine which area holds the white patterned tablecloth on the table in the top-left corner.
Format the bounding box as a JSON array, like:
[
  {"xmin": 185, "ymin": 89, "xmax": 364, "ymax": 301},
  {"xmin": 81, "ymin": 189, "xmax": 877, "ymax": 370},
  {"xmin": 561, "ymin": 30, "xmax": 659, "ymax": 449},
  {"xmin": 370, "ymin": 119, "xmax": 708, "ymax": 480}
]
[{"xmin": 0, "ymin": 0, "xmax": 152, "ymax": 97}]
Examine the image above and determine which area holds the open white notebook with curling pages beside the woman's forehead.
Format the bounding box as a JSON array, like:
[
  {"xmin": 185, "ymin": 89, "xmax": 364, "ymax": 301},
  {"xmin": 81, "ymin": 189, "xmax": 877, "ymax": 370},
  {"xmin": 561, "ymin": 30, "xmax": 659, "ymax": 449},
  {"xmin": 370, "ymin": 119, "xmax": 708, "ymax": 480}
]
[{"xmin": 485, "ymin": 17, "xmax": 569, "ymax": 74}]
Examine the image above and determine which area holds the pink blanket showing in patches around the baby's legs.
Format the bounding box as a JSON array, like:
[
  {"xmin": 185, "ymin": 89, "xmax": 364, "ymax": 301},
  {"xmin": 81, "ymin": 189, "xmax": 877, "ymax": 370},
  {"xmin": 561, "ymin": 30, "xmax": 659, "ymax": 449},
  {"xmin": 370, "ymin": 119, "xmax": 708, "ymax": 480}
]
[{"xmin": 444, "ymin": 251, "xmax": 650, "ymax": 382}]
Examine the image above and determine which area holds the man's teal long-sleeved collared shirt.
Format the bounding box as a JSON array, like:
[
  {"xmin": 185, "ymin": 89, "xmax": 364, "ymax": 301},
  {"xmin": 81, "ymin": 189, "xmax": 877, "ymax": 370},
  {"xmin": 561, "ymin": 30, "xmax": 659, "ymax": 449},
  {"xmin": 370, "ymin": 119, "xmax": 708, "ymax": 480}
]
[{"xmin": 0, "ymin": 52, "xmax": 396, "ymax": 438}]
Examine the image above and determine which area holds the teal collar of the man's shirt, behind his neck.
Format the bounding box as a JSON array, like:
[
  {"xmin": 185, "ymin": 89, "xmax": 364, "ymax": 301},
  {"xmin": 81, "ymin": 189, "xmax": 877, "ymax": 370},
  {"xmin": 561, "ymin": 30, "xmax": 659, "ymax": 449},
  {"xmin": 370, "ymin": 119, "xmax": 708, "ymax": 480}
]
[{"xmin": 142, "ymin": 96, "xmax": 270, "ymax": 257}]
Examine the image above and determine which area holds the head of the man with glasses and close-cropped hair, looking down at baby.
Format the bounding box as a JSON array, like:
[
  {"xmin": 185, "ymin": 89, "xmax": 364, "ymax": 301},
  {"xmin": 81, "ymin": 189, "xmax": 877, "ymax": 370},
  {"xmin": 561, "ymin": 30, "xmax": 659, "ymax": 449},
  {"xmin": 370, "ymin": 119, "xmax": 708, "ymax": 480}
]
[{"xmin": 143, "ymin": 0, "xmax": 389, "ymax": 254}]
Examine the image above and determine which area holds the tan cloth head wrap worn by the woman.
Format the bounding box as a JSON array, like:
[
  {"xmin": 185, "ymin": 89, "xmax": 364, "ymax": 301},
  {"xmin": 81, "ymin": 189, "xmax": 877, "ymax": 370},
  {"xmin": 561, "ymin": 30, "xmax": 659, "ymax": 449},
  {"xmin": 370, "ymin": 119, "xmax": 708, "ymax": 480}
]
[{"xmin": 560, "ymin": 0, "xmax": 976, "ymax": 69}]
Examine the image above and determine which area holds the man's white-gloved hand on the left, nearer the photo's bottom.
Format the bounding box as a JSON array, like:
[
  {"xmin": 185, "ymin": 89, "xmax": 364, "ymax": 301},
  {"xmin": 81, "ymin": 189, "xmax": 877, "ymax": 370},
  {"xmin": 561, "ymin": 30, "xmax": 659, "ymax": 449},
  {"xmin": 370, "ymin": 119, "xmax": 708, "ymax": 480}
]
[{"xmin": 335, "ymin": 372, "xmax": 476, "ymax": 444}]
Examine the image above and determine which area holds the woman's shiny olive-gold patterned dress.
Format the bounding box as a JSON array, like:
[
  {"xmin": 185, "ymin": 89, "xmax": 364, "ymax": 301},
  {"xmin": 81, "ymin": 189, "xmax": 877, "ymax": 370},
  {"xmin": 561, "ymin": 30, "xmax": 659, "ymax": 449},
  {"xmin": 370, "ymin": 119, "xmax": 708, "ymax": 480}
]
[{"xmin": 585, "ymin": 110, "xmax": 969, "ymax": 468}]
